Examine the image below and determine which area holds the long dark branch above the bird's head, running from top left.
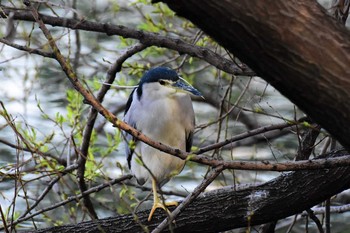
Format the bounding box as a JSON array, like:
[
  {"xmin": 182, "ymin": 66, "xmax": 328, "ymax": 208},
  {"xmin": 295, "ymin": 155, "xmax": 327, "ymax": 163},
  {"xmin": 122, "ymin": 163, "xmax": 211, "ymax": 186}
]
[{"xmin": 0, "ymin": 5, "xmax": 255, "ymax": 76}]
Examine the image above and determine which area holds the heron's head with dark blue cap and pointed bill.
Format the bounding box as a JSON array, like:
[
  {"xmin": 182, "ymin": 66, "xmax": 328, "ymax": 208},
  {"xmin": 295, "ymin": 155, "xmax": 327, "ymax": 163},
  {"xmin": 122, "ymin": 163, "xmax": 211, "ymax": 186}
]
[{"xmin": 137, "ymin": 67, "xmax": 202, "ymax": 97}]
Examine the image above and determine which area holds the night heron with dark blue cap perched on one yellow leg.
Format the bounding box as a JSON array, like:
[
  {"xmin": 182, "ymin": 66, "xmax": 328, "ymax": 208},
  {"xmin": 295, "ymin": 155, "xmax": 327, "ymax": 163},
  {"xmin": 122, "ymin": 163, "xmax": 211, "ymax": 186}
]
[{"xmin": 123, "ymin": 66, "xmax": 203, "ymax": 221}]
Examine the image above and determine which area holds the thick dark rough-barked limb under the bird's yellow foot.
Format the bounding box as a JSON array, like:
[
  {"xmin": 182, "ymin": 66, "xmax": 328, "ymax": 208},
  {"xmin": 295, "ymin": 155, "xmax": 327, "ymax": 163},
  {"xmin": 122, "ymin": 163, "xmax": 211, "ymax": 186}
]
[{"xmin": 26, "ymin": 152, "xmax": 350, "ymax": 233}]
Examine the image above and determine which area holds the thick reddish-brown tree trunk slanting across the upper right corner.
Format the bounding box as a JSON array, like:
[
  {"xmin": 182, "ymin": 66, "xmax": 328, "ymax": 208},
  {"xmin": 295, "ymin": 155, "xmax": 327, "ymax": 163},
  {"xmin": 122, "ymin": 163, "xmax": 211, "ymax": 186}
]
[{"xmin": 163, "ymin": 0, "xmax": 350, "ymax": 147}]
